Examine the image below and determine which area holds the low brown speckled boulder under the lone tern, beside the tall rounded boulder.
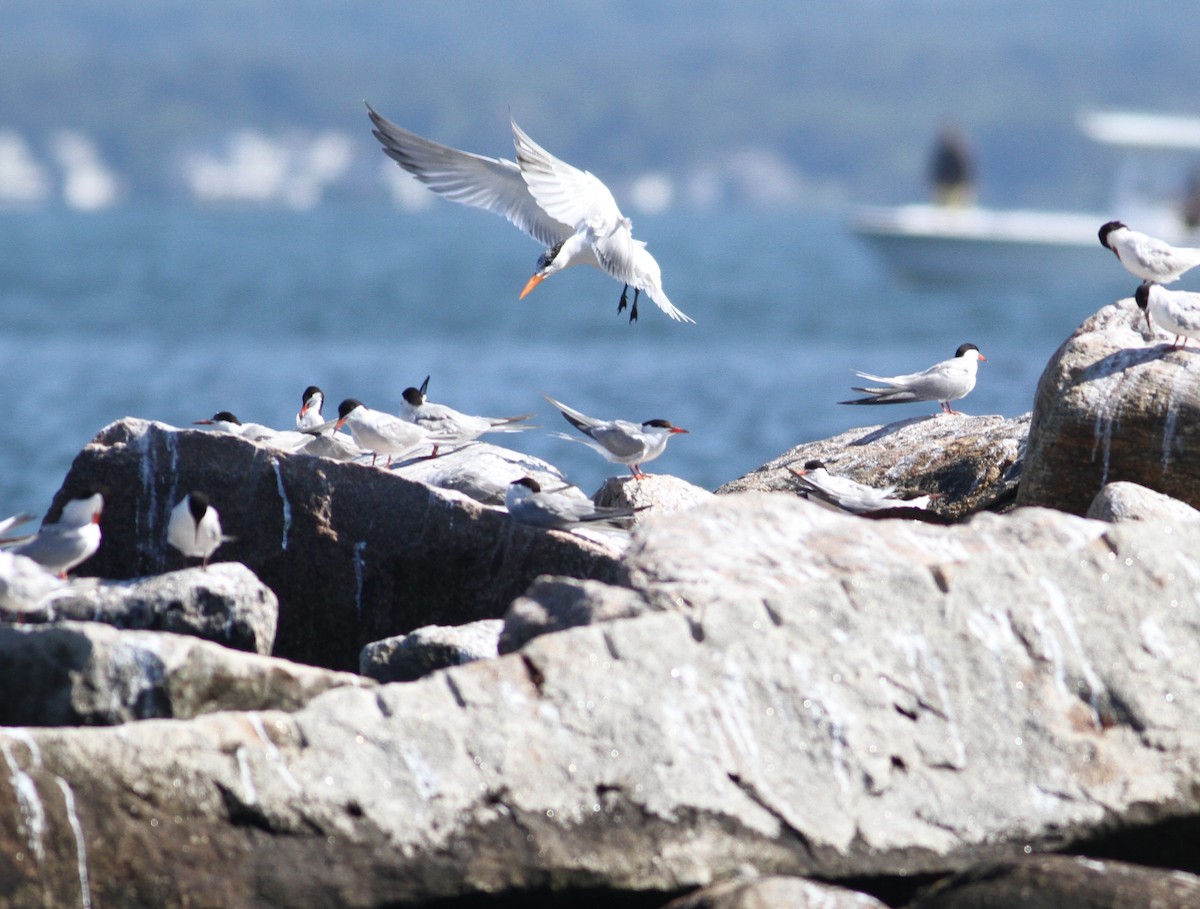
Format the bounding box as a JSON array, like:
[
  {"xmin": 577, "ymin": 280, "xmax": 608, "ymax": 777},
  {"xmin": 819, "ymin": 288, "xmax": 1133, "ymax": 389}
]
[{"xmin": 716, "ymin": 414, "xmax": 1030, "ymax": 518}]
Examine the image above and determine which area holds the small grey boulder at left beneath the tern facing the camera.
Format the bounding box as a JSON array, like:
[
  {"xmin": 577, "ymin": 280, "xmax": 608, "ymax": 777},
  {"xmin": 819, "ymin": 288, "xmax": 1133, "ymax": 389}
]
[{"xmin": 0, "ymin": 562, "xmax": 280, "ymax": 654}]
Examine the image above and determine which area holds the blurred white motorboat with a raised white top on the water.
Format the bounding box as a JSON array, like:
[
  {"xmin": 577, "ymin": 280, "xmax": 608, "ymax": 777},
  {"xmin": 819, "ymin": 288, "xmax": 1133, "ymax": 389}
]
[{"xmin": 850, "ymin": 112, "xmax": 1200, "ymax": 284}]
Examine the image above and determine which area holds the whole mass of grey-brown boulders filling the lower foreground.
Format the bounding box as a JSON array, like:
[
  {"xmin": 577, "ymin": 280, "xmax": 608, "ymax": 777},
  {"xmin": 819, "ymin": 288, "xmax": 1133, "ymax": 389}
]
[{"xmin": 0, "ymin": 300, "xmax": 1200, "ymax": 909}]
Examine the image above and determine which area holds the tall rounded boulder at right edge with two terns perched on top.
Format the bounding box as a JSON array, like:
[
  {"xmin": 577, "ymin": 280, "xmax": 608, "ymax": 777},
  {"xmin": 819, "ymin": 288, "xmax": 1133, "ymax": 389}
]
[{"xmin": 1018, "ymin": 299, "xmax": 1200, "ymax": 514}]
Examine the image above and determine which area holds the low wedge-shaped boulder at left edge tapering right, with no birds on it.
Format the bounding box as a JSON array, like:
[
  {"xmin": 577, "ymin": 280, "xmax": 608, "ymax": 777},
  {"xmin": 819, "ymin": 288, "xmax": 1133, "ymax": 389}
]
[{"xmin": 0, "ymin": 621, "xmax": 371, "ymax": 726}]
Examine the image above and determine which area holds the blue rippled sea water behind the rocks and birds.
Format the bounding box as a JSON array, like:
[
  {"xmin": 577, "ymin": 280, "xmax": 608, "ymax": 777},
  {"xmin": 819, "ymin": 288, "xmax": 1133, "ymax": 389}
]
[{"xmin": 0, "ymin": 204, "xmax": 1136, "ymax": 514}]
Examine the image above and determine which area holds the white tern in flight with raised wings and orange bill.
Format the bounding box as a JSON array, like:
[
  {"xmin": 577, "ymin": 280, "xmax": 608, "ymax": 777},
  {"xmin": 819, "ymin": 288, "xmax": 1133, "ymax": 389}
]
[{"xmin": 367, "ymin": 104, "xmax": 694, "ymax": 323}]
